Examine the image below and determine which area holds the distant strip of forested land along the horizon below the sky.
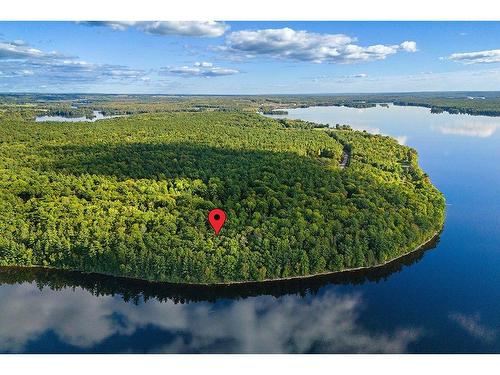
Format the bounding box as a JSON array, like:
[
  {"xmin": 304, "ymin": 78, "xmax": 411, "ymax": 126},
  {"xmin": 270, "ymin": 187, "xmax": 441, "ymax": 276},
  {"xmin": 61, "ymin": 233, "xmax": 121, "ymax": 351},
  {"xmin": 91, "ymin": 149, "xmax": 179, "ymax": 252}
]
[{"xmin": 0, "ymin": 91, "xmax": 500, "ymax": 118}]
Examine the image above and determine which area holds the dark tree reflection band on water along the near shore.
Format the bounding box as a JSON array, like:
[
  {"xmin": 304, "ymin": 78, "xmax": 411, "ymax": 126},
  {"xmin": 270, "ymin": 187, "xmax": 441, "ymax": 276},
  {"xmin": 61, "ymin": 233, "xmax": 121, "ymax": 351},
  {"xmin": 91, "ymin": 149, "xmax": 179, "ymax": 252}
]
[{"xmin": 0, "ymin": 234, "xmax": 440, "ymax": 303}]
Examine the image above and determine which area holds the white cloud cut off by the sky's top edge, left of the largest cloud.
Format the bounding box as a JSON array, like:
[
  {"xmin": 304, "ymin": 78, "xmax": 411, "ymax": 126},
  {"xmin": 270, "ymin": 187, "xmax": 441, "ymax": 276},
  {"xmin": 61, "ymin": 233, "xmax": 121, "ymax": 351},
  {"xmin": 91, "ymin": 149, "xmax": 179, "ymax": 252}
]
[{"xmin": 84, "ymin": 21, "xmax": 229, "ymax": 37}]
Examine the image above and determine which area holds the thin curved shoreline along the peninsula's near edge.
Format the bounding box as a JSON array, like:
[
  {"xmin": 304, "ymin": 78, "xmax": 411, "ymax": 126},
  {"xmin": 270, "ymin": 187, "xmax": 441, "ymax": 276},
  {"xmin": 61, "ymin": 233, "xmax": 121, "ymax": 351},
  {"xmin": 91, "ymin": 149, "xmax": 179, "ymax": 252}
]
[{"xmin": 0, "ymin": 228, "xmax": 444, "ymax": 288}]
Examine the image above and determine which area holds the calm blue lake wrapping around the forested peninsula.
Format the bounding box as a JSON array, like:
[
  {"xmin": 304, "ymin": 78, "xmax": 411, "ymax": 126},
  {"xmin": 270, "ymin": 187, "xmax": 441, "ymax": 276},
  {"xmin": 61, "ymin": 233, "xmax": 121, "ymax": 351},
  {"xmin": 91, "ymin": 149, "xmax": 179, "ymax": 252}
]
[{"xmin": 0, "ymin": 107, "xmax": 500, "ymax": 353}]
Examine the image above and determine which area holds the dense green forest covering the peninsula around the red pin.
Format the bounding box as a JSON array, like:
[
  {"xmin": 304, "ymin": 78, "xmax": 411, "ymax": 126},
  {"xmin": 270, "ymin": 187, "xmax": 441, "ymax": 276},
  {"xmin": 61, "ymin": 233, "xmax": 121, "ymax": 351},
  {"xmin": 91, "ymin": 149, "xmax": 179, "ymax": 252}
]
[{"xmin": 0, "ymin": 108, "xmax": 444, "ymax": 283}]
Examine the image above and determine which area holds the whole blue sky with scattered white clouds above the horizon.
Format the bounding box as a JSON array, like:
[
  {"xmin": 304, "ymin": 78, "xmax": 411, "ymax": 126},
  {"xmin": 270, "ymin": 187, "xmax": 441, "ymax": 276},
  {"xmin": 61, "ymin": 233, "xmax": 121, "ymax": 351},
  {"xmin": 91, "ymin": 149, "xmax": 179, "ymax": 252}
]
[{"xmin": 0, "ymin": 21, "xmax": 500, "ymax": 94}]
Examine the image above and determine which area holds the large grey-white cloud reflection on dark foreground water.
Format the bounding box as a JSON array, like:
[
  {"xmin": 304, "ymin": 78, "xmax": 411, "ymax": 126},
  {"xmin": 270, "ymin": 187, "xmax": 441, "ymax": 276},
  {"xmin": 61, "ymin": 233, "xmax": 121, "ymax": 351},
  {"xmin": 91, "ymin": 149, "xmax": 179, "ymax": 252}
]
[{"xmin": 0, "ymin": 283, "xmax": 421, "ymax": 353}]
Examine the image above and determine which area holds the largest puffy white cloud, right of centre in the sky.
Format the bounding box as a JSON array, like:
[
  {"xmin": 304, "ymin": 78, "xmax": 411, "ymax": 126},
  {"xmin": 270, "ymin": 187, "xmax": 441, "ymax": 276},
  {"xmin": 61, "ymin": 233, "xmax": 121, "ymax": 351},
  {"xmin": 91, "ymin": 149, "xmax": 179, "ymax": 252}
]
[{"xmin": 224, "ymin": 28, "xmax": 417, "ymax": 63}]
